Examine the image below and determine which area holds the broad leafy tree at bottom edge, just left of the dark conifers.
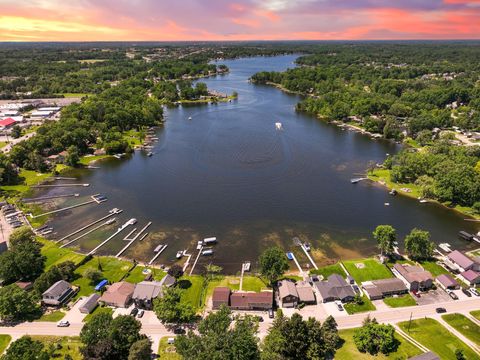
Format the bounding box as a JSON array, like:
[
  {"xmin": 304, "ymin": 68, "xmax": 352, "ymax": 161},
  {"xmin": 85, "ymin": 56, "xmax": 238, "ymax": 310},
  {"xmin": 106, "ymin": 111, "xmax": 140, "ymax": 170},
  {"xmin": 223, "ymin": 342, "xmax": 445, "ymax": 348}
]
[{"xmin": 175, "ymin": 306, "xmax": 260, "ymax": 360}]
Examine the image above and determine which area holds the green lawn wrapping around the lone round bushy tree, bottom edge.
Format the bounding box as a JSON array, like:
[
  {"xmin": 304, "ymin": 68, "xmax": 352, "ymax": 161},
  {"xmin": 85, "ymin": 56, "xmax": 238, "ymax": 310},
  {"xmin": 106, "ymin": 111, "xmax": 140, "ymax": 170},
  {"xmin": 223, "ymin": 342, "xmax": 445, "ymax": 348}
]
[{"xmin": 335, "ymin": 329, "xmax": 422, "ymax": 360}]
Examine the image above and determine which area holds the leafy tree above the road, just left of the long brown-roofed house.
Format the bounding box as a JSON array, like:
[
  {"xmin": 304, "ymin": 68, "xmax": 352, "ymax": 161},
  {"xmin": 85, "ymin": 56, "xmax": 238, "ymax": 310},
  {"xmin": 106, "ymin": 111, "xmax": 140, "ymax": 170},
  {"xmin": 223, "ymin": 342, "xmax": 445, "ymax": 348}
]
[{"xmin": 153, "ymin": 288, "xmax": 195, "ymax": 324}]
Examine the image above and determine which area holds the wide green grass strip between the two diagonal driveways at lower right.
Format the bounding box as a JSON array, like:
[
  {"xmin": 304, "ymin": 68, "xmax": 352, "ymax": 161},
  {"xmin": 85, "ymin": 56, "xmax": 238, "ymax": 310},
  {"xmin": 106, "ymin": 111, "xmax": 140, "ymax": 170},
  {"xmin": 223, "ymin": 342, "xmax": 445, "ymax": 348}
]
[{"xmin": 398, "ymin": 318, "xmax": 480, "ymax": 360}]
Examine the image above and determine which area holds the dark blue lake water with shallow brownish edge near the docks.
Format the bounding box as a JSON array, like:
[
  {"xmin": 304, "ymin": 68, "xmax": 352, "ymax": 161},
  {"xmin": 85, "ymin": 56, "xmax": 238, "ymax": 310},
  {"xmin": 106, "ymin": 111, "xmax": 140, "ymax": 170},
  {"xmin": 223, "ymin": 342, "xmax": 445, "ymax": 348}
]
[{"xmin": 43, "ymin": 56, "xmax": 479, "ymax": 273}]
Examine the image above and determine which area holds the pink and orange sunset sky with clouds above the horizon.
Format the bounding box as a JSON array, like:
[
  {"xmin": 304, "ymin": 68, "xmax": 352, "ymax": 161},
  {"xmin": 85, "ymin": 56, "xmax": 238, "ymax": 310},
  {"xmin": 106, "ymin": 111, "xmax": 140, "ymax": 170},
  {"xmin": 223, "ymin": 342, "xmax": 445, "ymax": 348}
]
[{"xmin": 0, "ymin": 0, "xmax": 480, "ymax": 41}]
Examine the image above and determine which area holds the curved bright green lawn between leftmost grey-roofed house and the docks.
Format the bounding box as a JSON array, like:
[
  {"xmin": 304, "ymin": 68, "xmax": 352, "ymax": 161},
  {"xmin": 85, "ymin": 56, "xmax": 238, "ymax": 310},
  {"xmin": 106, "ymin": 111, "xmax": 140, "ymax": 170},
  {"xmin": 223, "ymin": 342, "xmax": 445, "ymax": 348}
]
[{"xmin": 73, "ymin": 256, "xmax": 133, "ymax": 299}]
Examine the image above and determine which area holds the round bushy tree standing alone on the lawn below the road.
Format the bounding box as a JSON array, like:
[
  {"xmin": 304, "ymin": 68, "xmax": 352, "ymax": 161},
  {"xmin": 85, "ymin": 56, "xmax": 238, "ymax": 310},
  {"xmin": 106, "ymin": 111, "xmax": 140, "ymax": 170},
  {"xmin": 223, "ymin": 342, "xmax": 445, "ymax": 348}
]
[{"xmin": 353, "ymin": 317, "xmax": 399, "ymax": 355}]
